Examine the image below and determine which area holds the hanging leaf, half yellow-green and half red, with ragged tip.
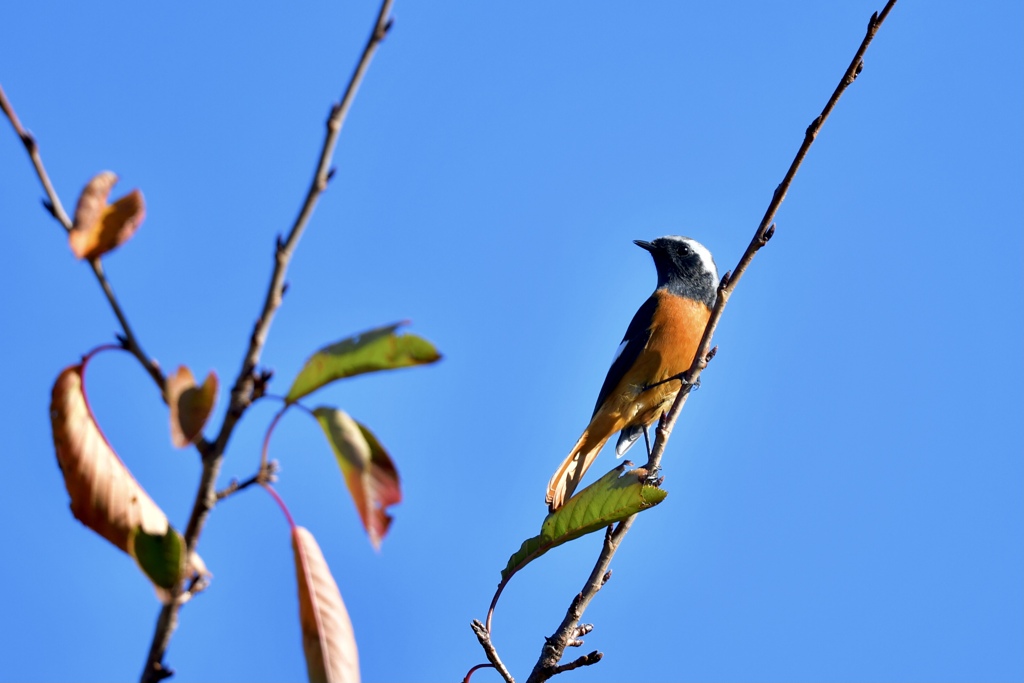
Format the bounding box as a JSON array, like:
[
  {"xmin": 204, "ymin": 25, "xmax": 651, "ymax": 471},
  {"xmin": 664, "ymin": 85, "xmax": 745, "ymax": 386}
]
[{"xmin": 313, "ymin": 405, "xmax": 401, "ymax": 549}]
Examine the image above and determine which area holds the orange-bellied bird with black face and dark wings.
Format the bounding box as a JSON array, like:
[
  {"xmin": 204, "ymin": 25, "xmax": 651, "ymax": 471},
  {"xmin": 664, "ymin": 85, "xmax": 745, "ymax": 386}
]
[{"xmin": 545, "ymin": 234, "xmax": 719, "ymax": 512}]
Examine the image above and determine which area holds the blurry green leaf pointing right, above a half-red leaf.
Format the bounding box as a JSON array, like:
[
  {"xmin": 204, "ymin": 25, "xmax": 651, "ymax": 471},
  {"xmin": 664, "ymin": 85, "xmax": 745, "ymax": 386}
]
[{"xmin": 285, "ymin": 323, "xmax": 441, "ymax": 403}]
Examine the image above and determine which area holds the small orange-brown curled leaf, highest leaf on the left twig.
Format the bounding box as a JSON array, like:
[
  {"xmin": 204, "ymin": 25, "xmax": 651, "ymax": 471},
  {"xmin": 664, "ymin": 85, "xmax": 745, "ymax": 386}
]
[{"xmin": 68, "ymin": 171, "xmax": 145, "ymax": 260}]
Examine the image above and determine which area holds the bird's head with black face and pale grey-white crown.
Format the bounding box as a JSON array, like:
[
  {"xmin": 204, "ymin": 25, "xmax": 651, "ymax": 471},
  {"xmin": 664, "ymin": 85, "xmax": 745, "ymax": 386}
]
[{"xmin": 636, "ymin": 237, "xmax": 718, "ymax": 308}]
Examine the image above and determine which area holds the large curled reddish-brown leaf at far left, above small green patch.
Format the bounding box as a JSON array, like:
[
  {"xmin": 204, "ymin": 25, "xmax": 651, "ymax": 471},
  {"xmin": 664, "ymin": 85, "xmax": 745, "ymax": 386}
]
[{"xmin": 50, "ymin": 365, "xmax": 168, "ymax": 554}]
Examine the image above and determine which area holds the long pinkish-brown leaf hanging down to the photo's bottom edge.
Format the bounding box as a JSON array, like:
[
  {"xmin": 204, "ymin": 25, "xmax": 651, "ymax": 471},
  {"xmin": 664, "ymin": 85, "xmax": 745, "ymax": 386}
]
[{"xmin": 292, "ymin": 526, "xmax": 359, "ymax": 683}]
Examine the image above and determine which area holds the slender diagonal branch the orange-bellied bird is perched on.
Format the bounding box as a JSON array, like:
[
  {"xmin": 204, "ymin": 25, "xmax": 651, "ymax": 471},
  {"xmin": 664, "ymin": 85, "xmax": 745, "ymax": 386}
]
[{"xmin": 516, "ymin": 0, "xmax": 896, "ymax": 683}]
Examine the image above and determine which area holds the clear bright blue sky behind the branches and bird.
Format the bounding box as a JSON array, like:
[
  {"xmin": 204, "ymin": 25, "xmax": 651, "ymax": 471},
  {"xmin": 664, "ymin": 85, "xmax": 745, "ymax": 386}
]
[{"xmin": 0, "ymin": 0, "xmax": 1024, "ymax": 681}]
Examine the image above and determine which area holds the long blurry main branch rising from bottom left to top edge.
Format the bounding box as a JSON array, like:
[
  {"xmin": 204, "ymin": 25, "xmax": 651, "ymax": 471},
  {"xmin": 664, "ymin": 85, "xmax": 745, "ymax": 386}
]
[{"xmin": 141, "ymin": 0, "xmax": 393, "ymax": 683}]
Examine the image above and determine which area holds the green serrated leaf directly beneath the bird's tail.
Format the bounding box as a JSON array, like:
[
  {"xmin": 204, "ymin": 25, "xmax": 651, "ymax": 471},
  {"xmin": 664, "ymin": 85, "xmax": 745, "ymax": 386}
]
[{"xmin": 502, "ymin": 463, "xmax": 669, "ymax": 584}]
